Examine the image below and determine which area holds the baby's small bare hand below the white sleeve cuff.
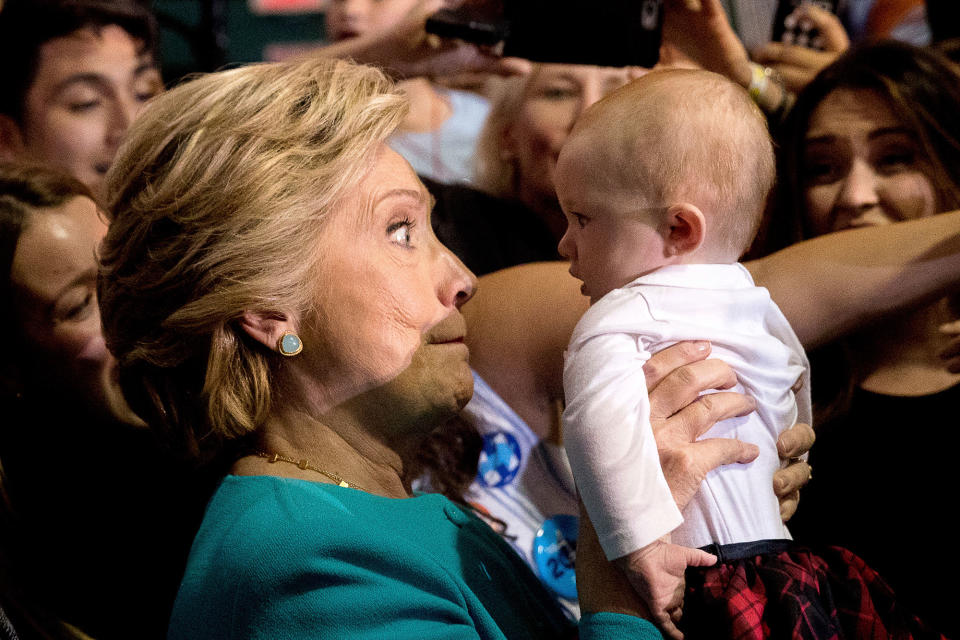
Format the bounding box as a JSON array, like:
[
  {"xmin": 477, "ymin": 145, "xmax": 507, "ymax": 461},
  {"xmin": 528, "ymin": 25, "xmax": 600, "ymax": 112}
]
[{"xmin": 616, "ymin": 536, "xmax": 717, "ymax": 640}]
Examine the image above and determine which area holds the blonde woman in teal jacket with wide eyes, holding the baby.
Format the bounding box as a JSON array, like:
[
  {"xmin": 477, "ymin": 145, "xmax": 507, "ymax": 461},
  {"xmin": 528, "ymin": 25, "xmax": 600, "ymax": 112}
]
[{"xmin": 100, "ymin": 53, "xmax": 804, "ymax": 638}]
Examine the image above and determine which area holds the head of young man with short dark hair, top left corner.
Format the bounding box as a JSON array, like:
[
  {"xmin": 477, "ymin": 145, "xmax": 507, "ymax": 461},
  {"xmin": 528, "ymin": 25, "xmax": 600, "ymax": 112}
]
[{"xmin": 0, "ymin": 0, "xmax": 163, "ymax": 198}]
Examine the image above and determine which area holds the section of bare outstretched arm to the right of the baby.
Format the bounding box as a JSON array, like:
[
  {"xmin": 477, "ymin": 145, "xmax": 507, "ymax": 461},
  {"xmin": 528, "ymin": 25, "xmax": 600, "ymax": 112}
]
[{"xmin": 746, "ymin": 211, "xmax": 960, "ymax": 349}]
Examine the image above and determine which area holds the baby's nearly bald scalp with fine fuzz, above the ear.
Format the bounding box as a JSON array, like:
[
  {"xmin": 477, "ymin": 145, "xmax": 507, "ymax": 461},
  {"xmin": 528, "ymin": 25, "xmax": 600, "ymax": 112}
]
[{"xmin": 562, "ymin": 69, "xmax": 775, "ymax": 261}]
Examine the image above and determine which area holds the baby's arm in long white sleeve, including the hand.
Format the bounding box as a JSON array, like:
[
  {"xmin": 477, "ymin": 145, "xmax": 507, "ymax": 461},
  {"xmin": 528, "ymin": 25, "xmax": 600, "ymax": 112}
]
[{"xmin": 563, "ymin": 334, "xmax": 716, "ymax": 638}]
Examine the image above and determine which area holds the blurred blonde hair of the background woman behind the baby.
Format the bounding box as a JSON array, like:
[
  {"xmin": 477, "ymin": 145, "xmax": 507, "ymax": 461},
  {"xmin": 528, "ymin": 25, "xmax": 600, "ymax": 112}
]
[{"xmin": 474, "ymin": 71, "xmax": 536, "ymax": 198}]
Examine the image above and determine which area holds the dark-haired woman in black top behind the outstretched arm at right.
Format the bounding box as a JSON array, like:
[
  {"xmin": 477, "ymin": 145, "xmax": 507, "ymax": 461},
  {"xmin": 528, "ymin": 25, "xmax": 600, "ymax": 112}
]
[{"xmin": 767, "ymin": 42, "xmax": 960, "ymax": 635}]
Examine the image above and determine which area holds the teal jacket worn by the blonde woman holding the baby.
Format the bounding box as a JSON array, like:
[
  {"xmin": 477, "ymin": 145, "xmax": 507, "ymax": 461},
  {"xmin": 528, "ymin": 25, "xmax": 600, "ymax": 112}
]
[{"xmin": 168, "ymin": 476, "xmax": 661, "ymax": 640}]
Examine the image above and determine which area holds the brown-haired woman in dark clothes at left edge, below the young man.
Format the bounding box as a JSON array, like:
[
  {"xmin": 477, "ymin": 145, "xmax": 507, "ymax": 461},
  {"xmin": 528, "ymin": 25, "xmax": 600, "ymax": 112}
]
[{"xmin": 0, "ymin": 164, "xmax": 214, "ymax": 638}]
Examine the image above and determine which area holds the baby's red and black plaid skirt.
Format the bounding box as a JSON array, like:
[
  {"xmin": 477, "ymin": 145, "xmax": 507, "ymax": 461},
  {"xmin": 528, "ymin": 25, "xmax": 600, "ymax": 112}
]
[{"xmin": 680, "ymin": 545, "xmax": 946, "ymax": 640}]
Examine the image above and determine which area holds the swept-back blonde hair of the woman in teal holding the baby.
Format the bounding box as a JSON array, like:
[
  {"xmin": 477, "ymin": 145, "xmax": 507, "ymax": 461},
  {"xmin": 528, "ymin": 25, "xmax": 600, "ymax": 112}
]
[{"xmin": 99, "ymin": 59, "xmax": 407, "ymax": 458}]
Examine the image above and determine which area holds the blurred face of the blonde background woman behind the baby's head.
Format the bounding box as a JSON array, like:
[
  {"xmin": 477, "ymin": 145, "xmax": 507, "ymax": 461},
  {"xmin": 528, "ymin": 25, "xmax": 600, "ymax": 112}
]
[{"xmin": 502, "ymin": 64, "xmax": 635, "ymax": 218}]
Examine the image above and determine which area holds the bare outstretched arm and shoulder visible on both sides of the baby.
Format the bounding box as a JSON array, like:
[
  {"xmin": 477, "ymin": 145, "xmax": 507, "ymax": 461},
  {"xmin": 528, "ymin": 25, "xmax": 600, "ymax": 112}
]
[{"xmin": 463, "ymin": 211, "xmax": 960, "ymax": 400}]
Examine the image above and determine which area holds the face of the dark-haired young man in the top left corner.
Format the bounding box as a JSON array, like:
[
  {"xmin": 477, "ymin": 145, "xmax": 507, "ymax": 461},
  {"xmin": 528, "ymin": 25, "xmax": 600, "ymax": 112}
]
[{"xmin": 0, "ymin": 25, "xmax": 162, "ymax": 198}]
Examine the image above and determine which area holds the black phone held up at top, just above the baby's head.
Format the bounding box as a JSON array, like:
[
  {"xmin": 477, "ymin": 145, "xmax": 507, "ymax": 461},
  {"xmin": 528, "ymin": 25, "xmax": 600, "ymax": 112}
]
[{"xmin": 427, "ymin": 0, "xmax": 663, "ymax": 67}]
